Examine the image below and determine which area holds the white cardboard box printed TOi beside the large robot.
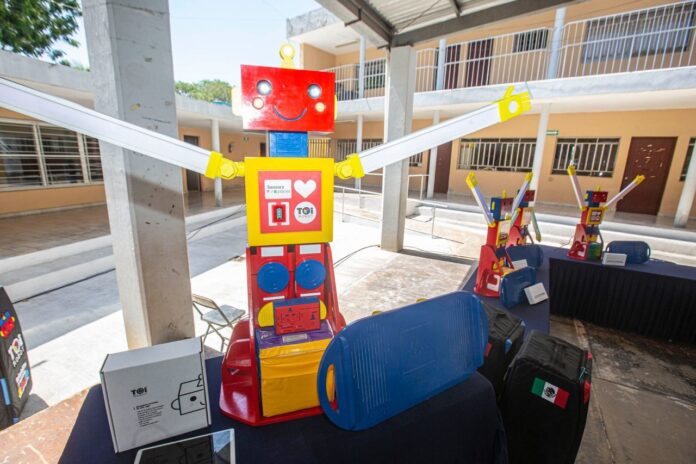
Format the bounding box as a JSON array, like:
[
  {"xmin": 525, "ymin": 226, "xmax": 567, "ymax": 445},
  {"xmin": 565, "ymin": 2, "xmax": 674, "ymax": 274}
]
[{"xmin": 101, "ymin": 338, "xmax": 210, "ymax": 453}]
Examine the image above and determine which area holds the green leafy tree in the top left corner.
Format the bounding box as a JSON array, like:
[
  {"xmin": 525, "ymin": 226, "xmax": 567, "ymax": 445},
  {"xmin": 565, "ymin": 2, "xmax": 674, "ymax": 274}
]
[{"xmin": 0, "ymin": 0, "xmax": 82, "ymax": 64}]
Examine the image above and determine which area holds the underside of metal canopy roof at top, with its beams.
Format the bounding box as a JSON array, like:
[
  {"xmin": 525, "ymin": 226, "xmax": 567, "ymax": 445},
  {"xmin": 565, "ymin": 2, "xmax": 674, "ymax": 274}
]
[{"xmin": 317, "ymin": 0, "xmax": 572, "ymax": 47}]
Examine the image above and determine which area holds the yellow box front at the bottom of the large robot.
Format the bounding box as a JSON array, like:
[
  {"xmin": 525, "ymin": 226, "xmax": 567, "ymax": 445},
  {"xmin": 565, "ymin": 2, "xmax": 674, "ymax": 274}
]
[{"xmin": 259, "ymin": 339, "xmax": 334, "ymax": 417}]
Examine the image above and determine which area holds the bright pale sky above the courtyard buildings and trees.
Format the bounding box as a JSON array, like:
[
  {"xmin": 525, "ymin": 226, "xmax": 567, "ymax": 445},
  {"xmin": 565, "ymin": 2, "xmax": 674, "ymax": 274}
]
[{"xmin": 57, "ymin": 0, "xmax": 319, "ymax": 84}]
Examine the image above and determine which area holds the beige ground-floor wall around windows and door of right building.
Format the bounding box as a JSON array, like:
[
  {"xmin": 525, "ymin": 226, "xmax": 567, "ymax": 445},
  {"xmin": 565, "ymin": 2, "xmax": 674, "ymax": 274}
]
[{"xmin": 450, "ymin": 110, "xmax": 696, "ymax": 216}]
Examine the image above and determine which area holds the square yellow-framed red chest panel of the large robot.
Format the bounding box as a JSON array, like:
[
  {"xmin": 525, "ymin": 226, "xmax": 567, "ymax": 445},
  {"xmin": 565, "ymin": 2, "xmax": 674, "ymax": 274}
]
[{"xmin": 244, "ymin": 158, "xmax": 334, "ymax": 246}]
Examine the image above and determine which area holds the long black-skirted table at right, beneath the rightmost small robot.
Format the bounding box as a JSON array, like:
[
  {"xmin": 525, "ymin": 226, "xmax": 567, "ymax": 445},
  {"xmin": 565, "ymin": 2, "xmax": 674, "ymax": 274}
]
[{"xmin": 544, "ymin": 247, "xmax": 696, "ymax": 343}]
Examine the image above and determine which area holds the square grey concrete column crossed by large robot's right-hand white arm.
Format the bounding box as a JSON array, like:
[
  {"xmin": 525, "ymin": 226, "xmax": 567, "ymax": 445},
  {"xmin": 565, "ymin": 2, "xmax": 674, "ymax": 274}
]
[{"xmin": 381, "ymin": 46, "xmax": 416, "ymax": 251}]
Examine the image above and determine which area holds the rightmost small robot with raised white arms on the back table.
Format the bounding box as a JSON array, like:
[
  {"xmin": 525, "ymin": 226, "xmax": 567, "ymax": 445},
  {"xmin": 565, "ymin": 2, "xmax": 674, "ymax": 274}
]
[{"xmin": 567, "ymin": 163, "xmax": 645, "ymax": 261}]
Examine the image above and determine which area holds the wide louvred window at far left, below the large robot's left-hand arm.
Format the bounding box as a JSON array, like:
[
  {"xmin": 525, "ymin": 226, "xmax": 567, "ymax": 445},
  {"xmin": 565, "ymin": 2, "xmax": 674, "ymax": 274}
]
[{"xmin": 0, "ymin": 121, "xmax": 103, "ymax": 190}]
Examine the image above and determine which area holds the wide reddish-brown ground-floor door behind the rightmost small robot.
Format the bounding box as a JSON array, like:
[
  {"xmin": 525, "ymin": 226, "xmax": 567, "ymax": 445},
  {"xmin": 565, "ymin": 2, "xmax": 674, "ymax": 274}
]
[{"xmin": 616, "ymin": 137, "xmax": 677, "ymax": 214}]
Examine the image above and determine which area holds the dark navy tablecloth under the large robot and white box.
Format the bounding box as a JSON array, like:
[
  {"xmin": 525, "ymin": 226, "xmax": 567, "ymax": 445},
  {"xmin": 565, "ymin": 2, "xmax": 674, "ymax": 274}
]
[{"xmin": 60, "ymin": 357, "xmax": 507, "ymax": 464}]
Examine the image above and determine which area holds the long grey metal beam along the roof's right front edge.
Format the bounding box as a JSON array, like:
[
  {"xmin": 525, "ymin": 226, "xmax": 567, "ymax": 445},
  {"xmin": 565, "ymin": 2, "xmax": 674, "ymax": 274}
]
[{"xmin": 392, "ymin": 0, "xmax": 573, "ymax": 47}]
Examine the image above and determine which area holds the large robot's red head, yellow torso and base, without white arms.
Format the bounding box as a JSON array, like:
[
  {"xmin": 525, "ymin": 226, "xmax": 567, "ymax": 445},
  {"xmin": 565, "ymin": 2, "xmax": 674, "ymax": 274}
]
[{"xmin": 220, "ymin": 45, "xmax": 362, "ymax": 425}]
